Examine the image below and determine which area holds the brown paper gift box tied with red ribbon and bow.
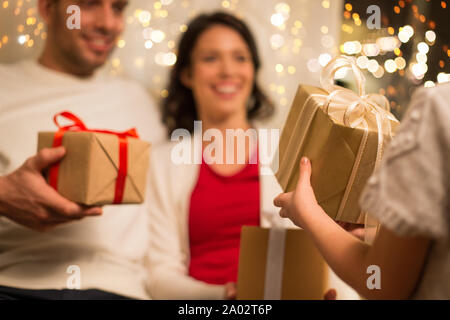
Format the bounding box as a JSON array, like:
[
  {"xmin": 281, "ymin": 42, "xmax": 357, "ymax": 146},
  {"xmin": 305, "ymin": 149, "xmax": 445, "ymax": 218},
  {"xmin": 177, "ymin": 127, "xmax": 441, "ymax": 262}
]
[{"xmin": 38, "ymin": 111, "xmax": 150, "ymax": 205}]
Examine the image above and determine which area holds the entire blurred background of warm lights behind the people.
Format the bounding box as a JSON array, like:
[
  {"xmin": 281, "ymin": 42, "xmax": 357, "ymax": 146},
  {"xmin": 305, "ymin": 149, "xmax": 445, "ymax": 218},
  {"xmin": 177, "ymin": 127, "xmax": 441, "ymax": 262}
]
[{"xmin": 0, "ymin": 0, "xmax": 450, "ymax": 128}]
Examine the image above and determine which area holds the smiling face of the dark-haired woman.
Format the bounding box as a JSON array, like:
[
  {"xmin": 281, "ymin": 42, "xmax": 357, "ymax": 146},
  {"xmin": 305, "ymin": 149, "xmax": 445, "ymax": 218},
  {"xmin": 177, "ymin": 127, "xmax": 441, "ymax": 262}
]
[{"xmin": 182, "ymin": 25, "xmax": 255, "ymax": 119}]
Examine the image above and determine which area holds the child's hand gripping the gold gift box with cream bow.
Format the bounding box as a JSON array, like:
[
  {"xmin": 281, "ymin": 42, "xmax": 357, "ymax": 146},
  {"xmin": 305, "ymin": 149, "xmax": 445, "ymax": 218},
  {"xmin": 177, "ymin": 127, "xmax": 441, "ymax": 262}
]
[{"xmin": 273, "ymin": 157, "xmax": 319, "ymax": 228}]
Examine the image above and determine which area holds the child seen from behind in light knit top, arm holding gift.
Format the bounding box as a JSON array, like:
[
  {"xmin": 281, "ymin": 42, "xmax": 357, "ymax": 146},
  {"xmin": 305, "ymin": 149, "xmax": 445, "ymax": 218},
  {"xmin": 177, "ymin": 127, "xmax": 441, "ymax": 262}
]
[{"xmin": 274, "ymin": 84, "xmax": 450, "ymax": 299}]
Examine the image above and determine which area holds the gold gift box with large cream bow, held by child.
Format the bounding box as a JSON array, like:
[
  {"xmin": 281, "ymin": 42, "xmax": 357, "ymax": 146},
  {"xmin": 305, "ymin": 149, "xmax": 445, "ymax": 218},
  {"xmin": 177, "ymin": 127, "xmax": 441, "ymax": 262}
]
[{"xmin": 274, "ymin": 56, "xmax": 399, "ymax": 223}]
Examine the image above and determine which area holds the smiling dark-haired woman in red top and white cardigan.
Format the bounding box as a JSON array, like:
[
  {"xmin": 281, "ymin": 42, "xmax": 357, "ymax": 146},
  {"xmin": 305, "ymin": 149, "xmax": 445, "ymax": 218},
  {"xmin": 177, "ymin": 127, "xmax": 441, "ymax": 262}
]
[{"xmin": 149, "ymin": 13, "xmax": 295, "ymax": 299}]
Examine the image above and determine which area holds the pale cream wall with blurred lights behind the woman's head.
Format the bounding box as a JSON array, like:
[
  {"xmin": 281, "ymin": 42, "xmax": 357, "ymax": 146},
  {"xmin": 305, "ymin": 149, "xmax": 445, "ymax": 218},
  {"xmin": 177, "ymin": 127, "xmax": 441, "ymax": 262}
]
[{"xmin": 0, "ymin": 0, "xmax": 343, "ymax": 127}]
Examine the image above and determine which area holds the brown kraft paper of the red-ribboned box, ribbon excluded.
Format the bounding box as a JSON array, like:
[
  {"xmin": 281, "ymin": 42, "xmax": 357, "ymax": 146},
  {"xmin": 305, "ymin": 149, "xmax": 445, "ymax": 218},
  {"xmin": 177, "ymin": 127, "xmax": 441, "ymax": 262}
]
[{"xmin": 38, "ymin": 131, "xmax": 150, "ymax": 205}]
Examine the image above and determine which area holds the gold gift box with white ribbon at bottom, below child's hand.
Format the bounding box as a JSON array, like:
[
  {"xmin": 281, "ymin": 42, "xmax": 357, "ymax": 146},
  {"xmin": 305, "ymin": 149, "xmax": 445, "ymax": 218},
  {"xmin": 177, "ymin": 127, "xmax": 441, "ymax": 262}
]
[{"xmin": 237, "ymin": 226, "xmax": 329, "ymax": 300}]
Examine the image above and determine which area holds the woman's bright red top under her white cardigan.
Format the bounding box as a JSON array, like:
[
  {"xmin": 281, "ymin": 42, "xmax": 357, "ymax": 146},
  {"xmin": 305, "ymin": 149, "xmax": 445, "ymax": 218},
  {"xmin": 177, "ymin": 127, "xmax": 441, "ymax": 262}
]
[{"xmin": 189, "ymin": 162, "xmax": 260, "ymax": 284}]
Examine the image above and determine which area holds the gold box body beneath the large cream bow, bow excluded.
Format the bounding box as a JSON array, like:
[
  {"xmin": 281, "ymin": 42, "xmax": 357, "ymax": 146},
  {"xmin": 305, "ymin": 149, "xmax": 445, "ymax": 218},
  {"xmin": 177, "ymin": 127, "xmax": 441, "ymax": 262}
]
[{"xmin": 275, "ymin": 57, "xmax": 398, "ymax": 224}]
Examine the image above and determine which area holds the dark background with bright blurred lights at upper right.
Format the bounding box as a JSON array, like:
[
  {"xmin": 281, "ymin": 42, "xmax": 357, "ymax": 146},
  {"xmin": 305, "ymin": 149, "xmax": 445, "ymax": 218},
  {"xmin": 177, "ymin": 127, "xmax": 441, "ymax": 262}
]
[{"xmin": 339, "ymin": 0, "xmax": 450, "ymax": 117}]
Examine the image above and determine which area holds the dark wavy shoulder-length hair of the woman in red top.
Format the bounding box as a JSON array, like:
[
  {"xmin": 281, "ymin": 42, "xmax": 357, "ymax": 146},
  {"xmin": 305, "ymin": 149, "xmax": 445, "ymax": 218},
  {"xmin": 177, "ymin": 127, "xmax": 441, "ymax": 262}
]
[{"xmin": 161, "ymin": 12, "xmax": 274, "ymax": 136}]
